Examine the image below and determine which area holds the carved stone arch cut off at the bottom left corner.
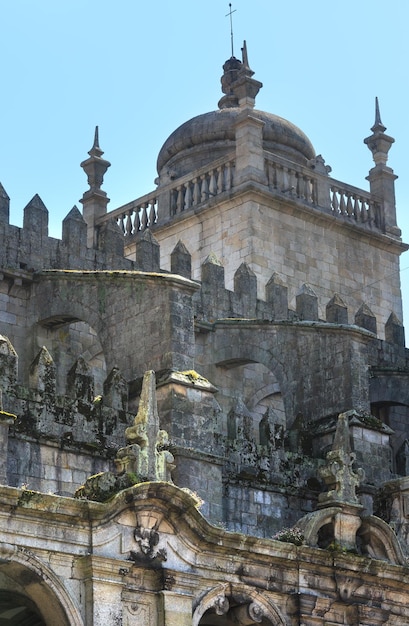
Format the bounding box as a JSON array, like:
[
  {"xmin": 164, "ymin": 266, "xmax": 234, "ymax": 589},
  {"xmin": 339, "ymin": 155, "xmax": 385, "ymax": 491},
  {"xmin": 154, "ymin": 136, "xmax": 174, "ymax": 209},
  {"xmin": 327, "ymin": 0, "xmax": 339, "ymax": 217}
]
[{"xmin": 0, "ymin": 544, "xmax": 84, "ymax": 626}]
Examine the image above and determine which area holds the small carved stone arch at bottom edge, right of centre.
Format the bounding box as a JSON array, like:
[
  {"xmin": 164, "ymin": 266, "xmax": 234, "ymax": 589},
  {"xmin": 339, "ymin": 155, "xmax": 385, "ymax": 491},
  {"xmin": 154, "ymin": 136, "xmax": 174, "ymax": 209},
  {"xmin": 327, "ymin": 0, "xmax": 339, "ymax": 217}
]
[{"xmin": 192, "ymin": 583, "xmax": 285, "ymax": 626}]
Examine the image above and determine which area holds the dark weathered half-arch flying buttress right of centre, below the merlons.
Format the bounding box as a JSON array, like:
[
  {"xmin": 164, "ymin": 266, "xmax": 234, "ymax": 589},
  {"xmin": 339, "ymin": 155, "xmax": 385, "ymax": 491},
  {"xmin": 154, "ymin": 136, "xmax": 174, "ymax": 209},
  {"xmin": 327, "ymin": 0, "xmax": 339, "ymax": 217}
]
[{"xmin": 207, "ymin": 319, "xmax": 369, "ymax": 429}]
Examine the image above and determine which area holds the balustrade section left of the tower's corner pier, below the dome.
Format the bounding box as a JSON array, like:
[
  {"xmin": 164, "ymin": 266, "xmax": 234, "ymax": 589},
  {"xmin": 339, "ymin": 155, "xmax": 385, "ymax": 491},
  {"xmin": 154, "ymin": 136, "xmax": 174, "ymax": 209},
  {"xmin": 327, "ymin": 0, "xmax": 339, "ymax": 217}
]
[{"xmin": 98, "ymin": 153, "xmax": 235, "ymax": 237}]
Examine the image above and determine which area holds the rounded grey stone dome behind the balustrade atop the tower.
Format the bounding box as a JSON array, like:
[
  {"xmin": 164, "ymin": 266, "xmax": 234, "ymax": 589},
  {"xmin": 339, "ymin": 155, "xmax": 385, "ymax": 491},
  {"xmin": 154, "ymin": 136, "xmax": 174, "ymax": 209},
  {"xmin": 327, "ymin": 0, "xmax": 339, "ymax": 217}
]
[{"xmin": 157, "ymin": 106, "xmax": 315, "ymax": 178}]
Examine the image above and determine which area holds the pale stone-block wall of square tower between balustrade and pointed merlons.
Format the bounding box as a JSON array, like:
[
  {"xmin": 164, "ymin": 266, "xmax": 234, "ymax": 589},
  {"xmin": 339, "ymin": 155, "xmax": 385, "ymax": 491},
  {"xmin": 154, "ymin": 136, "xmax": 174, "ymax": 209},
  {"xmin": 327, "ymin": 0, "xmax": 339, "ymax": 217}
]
[{"xmin": 154, "ymin": 191, "xmax": 403, "ymax": 338}]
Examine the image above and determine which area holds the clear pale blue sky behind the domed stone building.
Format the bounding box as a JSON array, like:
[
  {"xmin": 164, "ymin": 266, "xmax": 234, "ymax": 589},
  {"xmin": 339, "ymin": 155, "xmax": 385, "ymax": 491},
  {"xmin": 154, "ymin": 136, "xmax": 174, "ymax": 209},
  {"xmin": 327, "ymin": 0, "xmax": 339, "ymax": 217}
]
[{"xmin": 0, "ymin": 0, "xmax": 409, "ymax": 326}]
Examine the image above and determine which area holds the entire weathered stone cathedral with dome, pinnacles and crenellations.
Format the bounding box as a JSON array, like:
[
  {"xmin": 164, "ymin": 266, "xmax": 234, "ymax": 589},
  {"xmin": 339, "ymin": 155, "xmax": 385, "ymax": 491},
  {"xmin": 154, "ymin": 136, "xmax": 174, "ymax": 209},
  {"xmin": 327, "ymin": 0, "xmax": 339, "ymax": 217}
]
[{"xmin": 0, "ymin": 44, "xmax": 409, "ymax": 626}]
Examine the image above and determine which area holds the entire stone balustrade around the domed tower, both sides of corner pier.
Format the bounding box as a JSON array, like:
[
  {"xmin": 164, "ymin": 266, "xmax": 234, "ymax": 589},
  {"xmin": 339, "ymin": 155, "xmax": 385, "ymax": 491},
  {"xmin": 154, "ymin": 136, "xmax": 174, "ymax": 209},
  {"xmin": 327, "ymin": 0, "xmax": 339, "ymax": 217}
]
[{"xmin": 98, "ymin": 152, "xmax": 384, "ymax": 237}]
